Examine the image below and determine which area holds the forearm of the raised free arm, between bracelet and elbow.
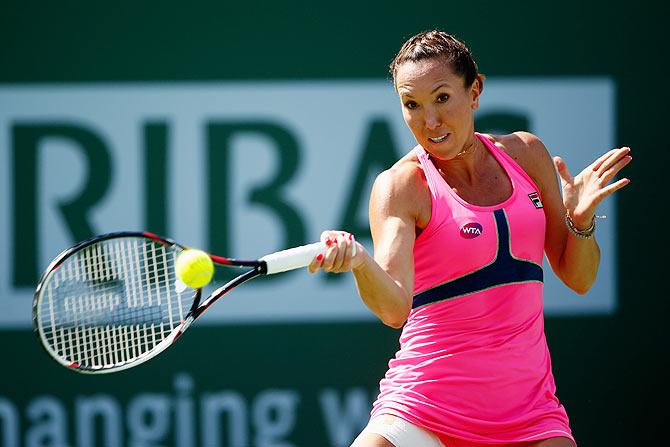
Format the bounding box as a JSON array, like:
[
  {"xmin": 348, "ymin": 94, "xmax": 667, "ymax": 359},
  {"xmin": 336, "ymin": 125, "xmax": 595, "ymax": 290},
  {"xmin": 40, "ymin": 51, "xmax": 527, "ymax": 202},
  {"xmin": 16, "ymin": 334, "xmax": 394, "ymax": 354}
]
[{"xmin": 560, "ymin": 233, "xmax": 600, "ymax": 295}]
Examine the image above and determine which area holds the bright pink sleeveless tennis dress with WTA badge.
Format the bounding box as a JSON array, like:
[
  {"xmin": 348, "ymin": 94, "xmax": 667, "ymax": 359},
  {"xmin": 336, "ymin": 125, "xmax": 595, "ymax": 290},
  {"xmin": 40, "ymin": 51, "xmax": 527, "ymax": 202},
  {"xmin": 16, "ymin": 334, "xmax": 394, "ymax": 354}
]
[{"xmin": 372, "ymin": 134, "xmax": 574, "ymax": 446}]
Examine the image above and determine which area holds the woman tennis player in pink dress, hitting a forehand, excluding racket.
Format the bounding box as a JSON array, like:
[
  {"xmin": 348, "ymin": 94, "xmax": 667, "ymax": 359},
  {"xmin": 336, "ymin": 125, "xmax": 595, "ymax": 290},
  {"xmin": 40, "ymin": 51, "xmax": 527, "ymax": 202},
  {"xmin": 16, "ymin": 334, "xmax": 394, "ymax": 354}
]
[{"xmin": 309, "ymin": 31, "xmax": 632, "ymax": 447}]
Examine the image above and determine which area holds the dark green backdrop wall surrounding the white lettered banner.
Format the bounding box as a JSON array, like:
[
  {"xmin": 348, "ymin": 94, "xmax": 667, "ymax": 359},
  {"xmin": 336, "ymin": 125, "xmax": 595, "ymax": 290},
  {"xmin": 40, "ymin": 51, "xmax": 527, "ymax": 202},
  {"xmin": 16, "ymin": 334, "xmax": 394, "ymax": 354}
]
[{"xmin": 0, "ymin": 0, "xmax": 669, "ymax": 446}]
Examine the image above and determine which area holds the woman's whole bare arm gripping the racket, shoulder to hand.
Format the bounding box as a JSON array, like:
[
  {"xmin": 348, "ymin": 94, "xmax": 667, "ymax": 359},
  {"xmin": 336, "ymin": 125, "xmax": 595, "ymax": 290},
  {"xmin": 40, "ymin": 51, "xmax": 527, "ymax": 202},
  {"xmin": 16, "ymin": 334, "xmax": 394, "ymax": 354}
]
[{"xmin": 310, "ymin": 164, "xmax": 425, "ymax": 328}]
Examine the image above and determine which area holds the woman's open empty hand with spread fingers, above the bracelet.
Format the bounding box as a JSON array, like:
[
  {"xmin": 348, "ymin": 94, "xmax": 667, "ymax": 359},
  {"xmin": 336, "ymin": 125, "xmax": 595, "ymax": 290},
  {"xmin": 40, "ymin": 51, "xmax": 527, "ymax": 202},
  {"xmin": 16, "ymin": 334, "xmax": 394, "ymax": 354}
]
[{"xmin": 554, "ymin": 147, "xmax": 633, "ymax": 229}]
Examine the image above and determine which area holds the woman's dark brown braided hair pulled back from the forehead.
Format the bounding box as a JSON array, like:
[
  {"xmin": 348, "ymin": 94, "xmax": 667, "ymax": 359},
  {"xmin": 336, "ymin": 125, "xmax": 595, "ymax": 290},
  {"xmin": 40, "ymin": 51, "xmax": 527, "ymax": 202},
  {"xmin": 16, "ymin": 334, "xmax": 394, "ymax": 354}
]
[{"xmin": 389, "ymin": 30, "xmax": 484, "ymax": 87}]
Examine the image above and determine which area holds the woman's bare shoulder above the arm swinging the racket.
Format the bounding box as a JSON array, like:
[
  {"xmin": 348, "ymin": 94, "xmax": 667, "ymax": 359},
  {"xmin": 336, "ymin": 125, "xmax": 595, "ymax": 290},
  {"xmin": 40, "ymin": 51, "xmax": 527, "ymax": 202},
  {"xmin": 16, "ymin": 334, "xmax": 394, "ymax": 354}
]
[{"xmin": 370, "ymin": 152, "xmax": 431, "ymax": 227}]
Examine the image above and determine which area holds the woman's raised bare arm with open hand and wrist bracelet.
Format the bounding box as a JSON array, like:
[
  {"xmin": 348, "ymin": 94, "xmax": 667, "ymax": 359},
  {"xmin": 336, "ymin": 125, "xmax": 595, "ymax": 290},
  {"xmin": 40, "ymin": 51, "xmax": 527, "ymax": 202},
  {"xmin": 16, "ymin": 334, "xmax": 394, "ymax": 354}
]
[{"xmin": 515, "ymin": 132, "xmax": 632, "ymax": 294}]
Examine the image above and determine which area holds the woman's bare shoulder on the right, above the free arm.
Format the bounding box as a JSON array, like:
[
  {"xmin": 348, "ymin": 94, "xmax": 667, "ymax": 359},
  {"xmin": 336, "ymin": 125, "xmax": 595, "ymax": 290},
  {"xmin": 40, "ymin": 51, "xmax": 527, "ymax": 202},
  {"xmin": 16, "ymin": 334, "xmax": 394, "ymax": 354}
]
[{"xmin": 485, "ymin": 132, "xmax": 556, "ymax": 189}]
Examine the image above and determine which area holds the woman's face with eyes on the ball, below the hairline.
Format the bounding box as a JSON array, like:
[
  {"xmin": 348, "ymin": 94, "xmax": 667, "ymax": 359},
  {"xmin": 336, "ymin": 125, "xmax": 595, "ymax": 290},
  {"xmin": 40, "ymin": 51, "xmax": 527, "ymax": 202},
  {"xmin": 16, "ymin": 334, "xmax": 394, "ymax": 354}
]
[{"xmin": 395, "ymin": 59, "xmax": 481, "ymax": 160}]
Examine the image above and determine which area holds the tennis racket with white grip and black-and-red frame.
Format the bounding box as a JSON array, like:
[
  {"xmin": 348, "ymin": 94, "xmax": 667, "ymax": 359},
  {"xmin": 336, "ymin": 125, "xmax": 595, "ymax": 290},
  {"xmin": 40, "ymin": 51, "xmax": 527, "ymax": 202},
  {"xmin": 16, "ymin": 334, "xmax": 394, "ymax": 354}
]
[{"xmin": 33, "ymin": 232, "xmax": 334, "ymax": 373}]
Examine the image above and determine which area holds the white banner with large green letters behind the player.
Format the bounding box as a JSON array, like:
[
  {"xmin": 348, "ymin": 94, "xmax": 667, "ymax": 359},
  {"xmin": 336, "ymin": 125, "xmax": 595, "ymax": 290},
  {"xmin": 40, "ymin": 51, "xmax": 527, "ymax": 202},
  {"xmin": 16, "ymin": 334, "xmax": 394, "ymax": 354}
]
[{"xmin": 0, "ymin": 78, "xmax": 617, "ymax": 328}]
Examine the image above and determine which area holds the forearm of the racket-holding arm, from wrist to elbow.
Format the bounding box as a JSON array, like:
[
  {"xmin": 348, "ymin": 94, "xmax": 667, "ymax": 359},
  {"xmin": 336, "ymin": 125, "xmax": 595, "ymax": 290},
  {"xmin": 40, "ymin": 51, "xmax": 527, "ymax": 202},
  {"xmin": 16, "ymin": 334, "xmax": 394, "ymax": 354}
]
[{"xmin": 352, "ymin": 252, "xmax": 412, "ymax": 328}]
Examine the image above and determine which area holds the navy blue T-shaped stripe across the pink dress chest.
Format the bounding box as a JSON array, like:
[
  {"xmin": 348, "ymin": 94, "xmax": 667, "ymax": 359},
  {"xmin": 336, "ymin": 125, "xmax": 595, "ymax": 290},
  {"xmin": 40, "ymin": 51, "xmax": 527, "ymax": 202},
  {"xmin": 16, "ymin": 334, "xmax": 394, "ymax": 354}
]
[{"xmin": 412, "ymin": 209, "xmax": 543, "ymax": 309}]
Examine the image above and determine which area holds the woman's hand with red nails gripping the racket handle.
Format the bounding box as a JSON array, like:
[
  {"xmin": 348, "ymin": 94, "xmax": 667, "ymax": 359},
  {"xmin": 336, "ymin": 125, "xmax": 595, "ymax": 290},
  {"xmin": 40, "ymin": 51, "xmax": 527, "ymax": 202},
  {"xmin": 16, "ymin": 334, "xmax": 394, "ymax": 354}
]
[{"xmin": 308, "ymin": 230, "xmax": 367, "ymax": 273}]
